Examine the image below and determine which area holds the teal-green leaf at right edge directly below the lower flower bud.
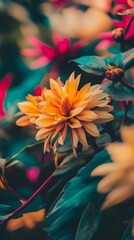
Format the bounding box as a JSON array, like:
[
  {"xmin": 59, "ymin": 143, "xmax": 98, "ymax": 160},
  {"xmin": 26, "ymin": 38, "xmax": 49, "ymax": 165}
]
[{"xmin": 102, "ymin": 82, "xmax": 134, "ymax": 101}]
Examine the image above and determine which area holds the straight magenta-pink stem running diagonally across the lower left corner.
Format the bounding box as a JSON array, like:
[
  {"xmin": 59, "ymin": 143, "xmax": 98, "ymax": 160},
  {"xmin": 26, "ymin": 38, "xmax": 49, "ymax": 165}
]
[{"xmin": 0, "ymin": 174, "xmax": 54, "ymax": 225}]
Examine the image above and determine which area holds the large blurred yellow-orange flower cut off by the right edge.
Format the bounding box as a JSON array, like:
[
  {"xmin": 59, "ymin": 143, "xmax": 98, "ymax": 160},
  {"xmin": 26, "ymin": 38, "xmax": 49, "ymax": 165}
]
[{"xmin": 91, "ymin": 125, "xmax": 134, "ymax": 209}]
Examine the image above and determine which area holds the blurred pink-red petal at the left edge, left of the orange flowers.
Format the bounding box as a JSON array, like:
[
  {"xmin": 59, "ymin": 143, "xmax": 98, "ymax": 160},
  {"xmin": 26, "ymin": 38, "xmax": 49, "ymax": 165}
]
[{"xmin": 0, "ymin": 73, "xmax": 13, "ymax": 120}]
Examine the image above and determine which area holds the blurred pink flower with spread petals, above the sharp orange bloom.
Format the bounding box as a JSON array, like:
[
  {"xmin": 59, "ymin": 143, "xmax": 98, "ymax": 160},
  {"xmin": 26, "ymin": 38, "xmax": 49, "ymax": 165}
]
[{"xmin": 21, "ymin": 34, "xmax": 85, "ymax": 69}]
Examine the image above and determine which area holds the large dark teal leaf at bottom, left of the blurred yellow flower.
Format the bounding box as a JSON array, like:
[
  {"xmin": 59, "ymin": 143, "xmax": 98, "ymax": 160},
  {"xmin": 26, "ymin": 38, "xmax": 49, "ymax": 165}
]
[{"xmin": 45, "ymin": 151, "xmax": 111, "ymax": 240}]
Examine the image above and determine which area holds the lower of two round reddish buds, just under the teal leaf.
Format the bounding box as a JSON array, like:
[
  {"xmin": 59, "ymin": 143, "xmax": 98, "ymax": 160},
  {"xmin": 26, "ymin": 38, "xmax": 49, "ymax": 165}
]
[{"xmin": 105, "ymin": 68, "xmax": 124, "ymax": 83}]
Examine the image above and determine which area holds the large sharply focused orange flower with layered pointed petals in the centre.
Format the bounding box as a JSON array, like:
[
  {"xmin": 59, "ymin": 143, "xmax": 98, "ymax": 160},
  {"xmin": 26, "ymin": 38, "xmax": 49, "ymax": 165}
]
[{"xmin": 35, "ymin": 73, "xmax": 113, "ymax": 155}]
